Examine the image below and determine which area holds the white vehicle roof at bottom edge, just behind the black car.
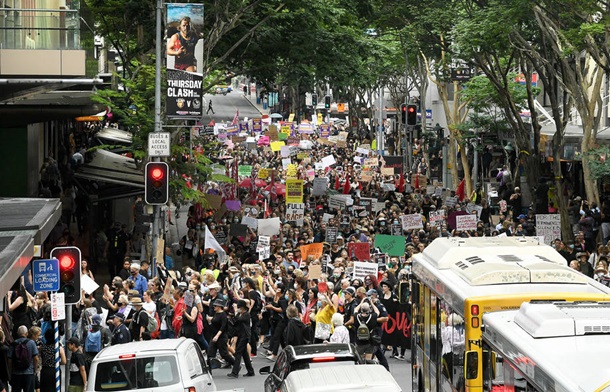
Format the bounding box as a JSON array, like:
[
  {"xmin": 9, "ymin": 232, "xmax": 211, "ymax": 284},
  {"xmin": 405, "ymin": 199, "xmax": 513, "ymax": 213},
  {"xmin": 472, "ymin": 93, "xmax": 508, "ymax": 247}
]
[{"xmin": 280, "ymin": 364, "xmax": 402, "ymax": 392}]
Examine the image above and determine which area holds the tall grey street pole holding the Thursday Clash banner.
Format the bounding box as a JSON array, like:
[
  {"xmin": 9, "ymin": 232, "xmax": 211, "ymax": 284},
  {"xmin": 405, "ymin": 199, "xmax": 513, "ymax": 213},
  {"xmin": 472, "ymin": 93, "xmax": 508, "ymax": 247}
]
[{"xmin": 151, "ymin": 0, "xmax": 163, "ymax": 278}]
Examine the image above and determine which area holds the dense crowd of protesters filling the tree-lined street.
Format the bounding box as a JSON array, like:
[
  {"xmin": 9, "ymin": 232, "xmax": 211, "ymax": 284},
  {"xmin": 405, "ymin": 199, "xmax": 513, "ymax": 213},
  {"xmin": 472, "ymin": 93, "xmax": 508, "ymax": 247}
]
[{"xmin": 0, "ymin": 118, "xmax": 610, "ymax": 391}]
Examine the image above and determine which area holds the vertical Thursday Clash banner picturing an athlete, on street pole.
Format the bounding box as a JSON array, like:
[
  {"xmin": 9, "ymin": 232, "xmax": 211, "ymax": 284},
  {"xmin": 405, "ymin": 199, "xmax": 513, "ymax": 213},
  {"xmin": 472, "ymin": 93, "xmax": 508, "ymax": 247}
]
[{"xmin": 165, "ymin": 3, "xmax": 204, "ymax": 118}]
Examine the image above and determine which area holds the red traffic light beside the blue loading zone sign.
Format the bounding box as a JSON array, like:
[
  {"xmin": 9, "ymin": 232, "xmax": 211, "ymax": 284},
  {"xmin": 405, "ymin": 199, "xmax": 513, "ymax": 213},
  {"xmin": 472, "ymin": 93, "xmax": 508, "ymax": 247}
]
[{"xmin": 51, "ymin": 246, "xmax": 81, "ymax": 305}]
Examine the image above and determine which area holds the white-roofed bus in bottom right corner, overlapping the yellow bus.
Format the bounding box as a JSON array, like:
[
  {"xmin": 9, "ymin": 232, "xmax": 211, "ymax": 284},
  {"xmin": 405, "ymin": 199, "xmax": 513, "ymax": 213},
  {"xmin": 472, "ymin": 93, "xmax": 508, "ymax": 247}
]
[{"xmin": 482, "ymin": 302, "xmax": 610, "ymax": 392}]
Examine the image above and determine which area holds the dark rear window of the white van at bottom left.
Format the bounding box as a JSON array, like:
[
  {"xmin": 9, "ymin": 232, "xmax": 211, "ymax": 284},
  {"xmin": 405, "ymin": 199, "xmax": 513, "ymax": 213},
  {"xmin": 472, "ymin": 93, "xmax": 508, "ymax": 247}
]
[{"xmin": 95, "ymin": 356, "xmax": 180, "ymax": 391}]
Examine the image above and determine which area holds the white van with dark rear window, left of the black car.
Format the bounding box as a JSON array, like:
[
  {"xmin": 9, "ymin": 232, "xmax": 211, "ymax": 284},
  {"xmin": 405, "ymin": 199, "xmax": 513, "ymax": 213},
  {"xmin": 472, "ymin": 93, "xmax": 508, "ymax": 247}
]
[{"xmin": 87, "ymin": 338, "xmax": 216, "ymax": 392}]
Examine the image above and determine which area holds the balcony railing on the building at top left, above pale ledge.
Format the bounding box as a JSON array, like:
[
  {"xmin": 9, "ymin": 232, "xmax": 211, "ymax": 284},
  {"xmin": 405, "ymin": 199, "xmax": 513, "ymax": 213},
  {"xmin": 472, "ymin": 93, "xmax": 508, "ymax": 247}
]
[{"xmin": 0, "ymin": 8, "xmax": 80, "ymax": 50}]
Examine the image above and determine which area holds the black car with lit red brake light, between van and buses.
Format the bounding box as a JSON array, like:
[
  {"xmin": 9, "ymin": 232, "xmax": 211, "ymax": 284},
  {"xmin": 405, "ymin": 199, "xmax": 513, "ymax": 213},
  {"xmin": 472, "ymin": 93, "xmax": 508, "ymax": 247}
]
[{"xmin": 259, "ymin": 343, "xmax": 363, "ymax": 392}]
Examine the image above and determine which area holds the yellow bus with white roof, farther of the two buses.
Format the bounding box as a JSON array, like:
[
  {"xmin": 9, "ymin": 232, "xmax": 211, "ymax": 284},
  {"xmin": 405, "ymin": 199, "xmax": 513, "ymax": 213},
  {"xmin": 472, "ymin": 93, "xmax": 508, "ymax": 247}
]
[{"xmin": 411, "ymin": 237, "xmax": 610, "ymax": 392}]
